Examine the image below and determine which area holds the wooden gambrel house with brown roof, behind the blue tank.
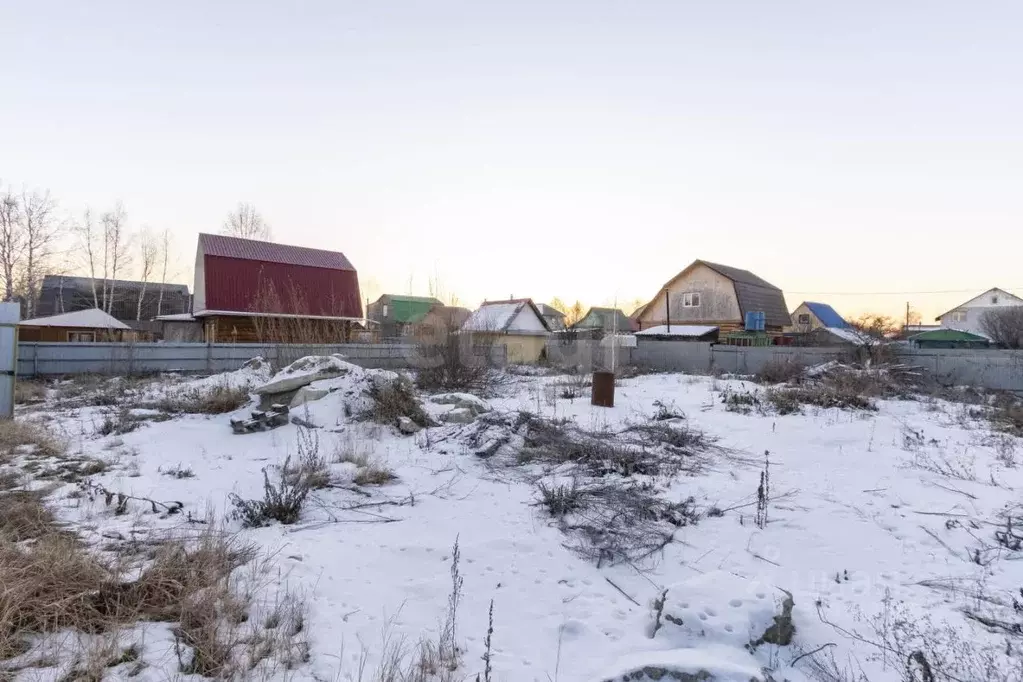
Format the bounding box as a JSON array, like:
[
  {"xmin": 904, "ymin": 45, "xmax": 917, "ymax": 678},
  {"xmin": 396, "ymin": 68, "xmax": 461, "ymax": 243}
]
[{"xmin": 634, "ymin": 261, "xmax": 791, "ymax": 335}]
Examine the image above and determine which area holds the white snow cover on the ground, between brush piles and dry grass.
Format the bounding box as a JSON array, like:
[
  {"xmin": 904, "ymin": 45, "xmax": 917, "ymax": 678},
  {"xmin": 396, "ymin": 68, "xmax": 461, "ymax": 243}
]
[{"xmin": 3, "ymin": 359, "xmax": 1023, "ymax": 682}]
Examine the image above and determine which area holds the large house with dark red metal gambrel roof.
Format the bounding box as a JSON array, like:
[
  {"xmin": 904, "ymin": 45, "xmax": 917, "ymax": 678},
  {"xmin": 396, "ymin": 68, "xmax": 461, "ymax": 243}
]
[{"xmin": 192, "ymin": 234, "xmax": 362, "ymax": 344}]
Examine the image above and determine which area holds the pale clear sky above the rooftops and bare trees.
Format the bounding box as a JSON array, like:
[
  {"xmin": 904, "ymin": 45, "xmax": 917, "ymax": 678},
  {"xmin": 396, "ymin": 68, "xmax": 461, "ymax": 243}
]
[{"xmin": 0, "ymin": 0, "xmax": 1023, "ymax": 320}]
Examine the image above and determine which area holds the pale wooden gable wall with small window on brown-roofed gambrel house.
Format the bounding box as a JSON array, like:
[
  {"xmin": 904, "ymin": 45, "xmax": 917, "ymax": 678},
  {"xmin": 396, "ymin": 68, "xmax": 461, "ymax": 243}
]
[{"xmin": 639, "ymin": 264, "xmax": 743, "ymax": 329}]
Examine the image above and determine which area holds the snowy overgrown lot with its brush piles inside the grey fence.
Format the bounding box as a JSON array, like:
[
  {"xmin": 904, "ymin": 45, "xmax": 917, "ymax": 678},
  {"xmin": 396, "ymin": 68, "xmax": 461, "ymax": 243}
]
[{"xmin": 0, "ymin": 360, "xmax": 1023, "ymax": 682}]
